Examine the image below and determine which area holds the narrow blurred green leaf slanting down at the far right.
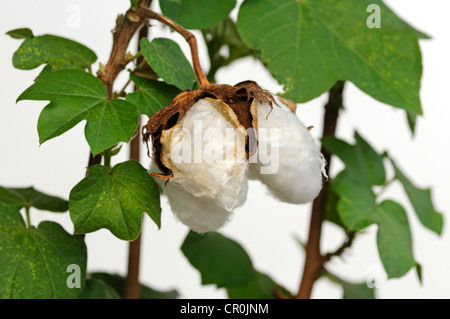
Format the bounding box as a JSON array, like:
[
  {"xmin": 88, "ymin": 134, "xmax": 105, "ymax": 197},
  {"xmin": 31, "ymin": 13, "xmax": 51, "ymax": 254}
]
[{"xmin": 391, "ymin": 159, "xmax": 443, "ymax": 235}]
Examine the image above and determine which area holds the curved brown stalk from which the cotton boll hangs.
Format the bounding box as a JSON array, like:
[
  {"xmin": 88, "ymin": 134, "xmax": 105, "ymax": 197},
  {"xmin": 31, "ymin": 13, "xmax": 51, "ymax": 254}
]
[{"xmin": 140, "ymin": 8, "xmax": 211, "ymax": 88}]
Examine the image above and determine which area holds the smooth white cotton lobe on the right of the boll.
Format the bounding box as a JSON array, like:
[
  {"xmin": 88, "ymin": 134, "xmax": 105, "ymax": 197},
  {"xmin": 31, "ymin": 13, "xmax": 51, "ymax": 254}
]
[{"xmin": 250, "ymin": 103, "xmax": 325, "ymax": 204}]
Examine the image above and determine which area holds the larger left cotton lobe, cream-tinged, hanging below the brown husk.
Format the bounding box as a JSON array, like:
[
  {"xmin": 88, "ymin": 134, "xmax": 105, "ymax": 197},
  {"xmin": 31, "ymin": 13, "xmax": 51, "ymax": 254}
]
[{"xmin": 156, "ymin": 99, "xmax": 248, "ymax": 233}]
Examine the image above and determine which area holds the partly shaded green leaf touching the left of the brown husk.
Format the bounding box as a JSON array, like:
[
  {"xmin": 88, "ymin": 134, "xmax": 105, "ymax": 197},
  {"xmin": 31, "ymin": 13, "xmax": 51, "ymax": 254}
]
[{"xmin": 126, "ymin": 73, "xmax": 180, "ymax": 117}]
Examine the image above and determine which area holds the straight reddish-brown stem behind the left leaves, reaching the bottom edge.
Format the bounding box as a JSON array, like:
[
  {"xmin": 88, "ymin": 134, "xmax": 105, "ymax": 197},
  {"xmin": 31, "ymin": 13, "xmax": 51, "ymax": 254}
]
[{"xmin": 123, "ymin": 21, "xmax": 148, "ymax": 299}]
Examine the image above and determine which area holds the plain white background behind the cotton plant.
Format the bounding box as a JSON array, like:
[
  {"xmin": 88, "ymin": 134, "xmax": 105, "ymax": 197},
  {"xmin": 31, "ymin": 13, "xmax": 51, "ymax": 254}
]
[{"xmin": 0, "ymin": 0, "xmax": 450, "ymax": 298}]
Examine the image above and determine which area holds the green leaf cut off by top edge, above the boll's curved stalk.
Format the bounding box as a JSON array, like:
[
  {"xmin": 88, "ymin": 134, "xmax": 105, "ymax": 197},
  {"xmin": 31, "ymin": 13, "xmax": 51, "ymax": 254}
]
[{"xmin": 159, "ymin": 0, "xmax": 236, "ymax": 29}]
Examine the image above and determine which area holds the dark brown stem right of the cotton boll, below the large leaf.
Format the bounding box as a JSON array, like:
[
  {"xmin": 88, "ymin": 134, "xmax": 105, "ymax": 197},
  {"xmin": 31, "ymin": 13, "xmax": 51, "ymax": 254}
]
[{"xmin": 296, "ymin": 81, "xmax": 344, "ymax": 299}]
